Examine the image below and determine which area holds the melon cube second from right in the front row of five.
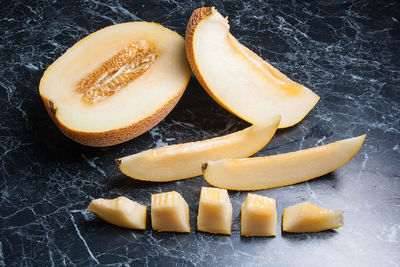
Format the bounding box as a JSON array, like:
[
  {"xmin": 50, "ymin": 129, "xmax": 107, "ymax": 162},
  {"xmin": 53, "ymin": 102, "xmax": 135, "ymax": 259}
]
[{"xmin": 241, "ymin": 193, "xmax": 277, "ymax": 236}]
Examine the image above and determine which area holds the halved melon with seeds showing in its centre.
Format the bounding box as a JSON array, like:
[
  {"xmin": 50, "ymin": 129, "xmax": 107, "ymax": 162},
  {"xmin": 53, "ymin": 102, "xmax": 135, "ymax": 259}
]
[{"xmin": 39, "ymin": 22, "xmax": 191, "ymax": 146}]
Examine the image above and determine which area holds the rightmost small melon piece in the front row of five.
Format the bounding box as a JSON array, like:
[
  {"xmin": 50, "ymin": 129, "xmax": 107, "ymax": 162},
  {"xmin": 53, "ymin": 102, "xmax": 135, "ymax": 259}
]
[{"xmin": 282, "ymin": 201, "xmax": 343, "ymax": 233}]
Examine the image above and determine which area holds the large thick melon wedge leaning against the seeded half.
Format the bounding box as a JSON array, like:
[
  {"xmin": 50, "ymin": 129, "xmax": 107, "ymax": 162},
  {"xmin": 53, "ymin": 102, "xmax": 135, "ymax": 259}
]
[{"xmin": 185, "ymin": 7, "xmax": 319, "ymax": 128}]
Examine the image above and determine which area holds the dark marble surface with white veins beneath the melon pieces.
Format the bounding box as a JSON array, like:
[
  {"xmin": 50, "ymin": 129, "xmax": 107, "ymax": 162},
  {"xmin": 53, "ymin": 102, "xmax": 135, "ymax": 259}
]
[{"xmin": 0, "ymin": 0, "xmax": 400, "ymax": 266}]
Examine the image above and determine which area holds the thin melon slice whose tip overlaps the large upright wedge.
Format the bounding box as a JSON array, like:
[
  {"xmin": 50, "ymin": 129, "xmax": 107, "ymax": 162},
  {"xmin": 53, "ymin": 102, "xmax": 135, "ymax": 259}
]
[{"xmin": 116, "ymin": 116, "xmax": 279, "ymax": 182}]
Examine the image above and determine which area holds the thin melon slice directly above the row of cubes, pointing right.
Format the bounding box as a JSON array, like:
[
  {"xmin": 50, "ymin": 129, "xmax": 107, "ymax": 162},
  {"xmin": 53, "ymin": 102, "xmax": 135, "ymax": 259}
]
[{"xmin": 203, "ymin": 135, "xmax": 365, "ymax": 190}]
